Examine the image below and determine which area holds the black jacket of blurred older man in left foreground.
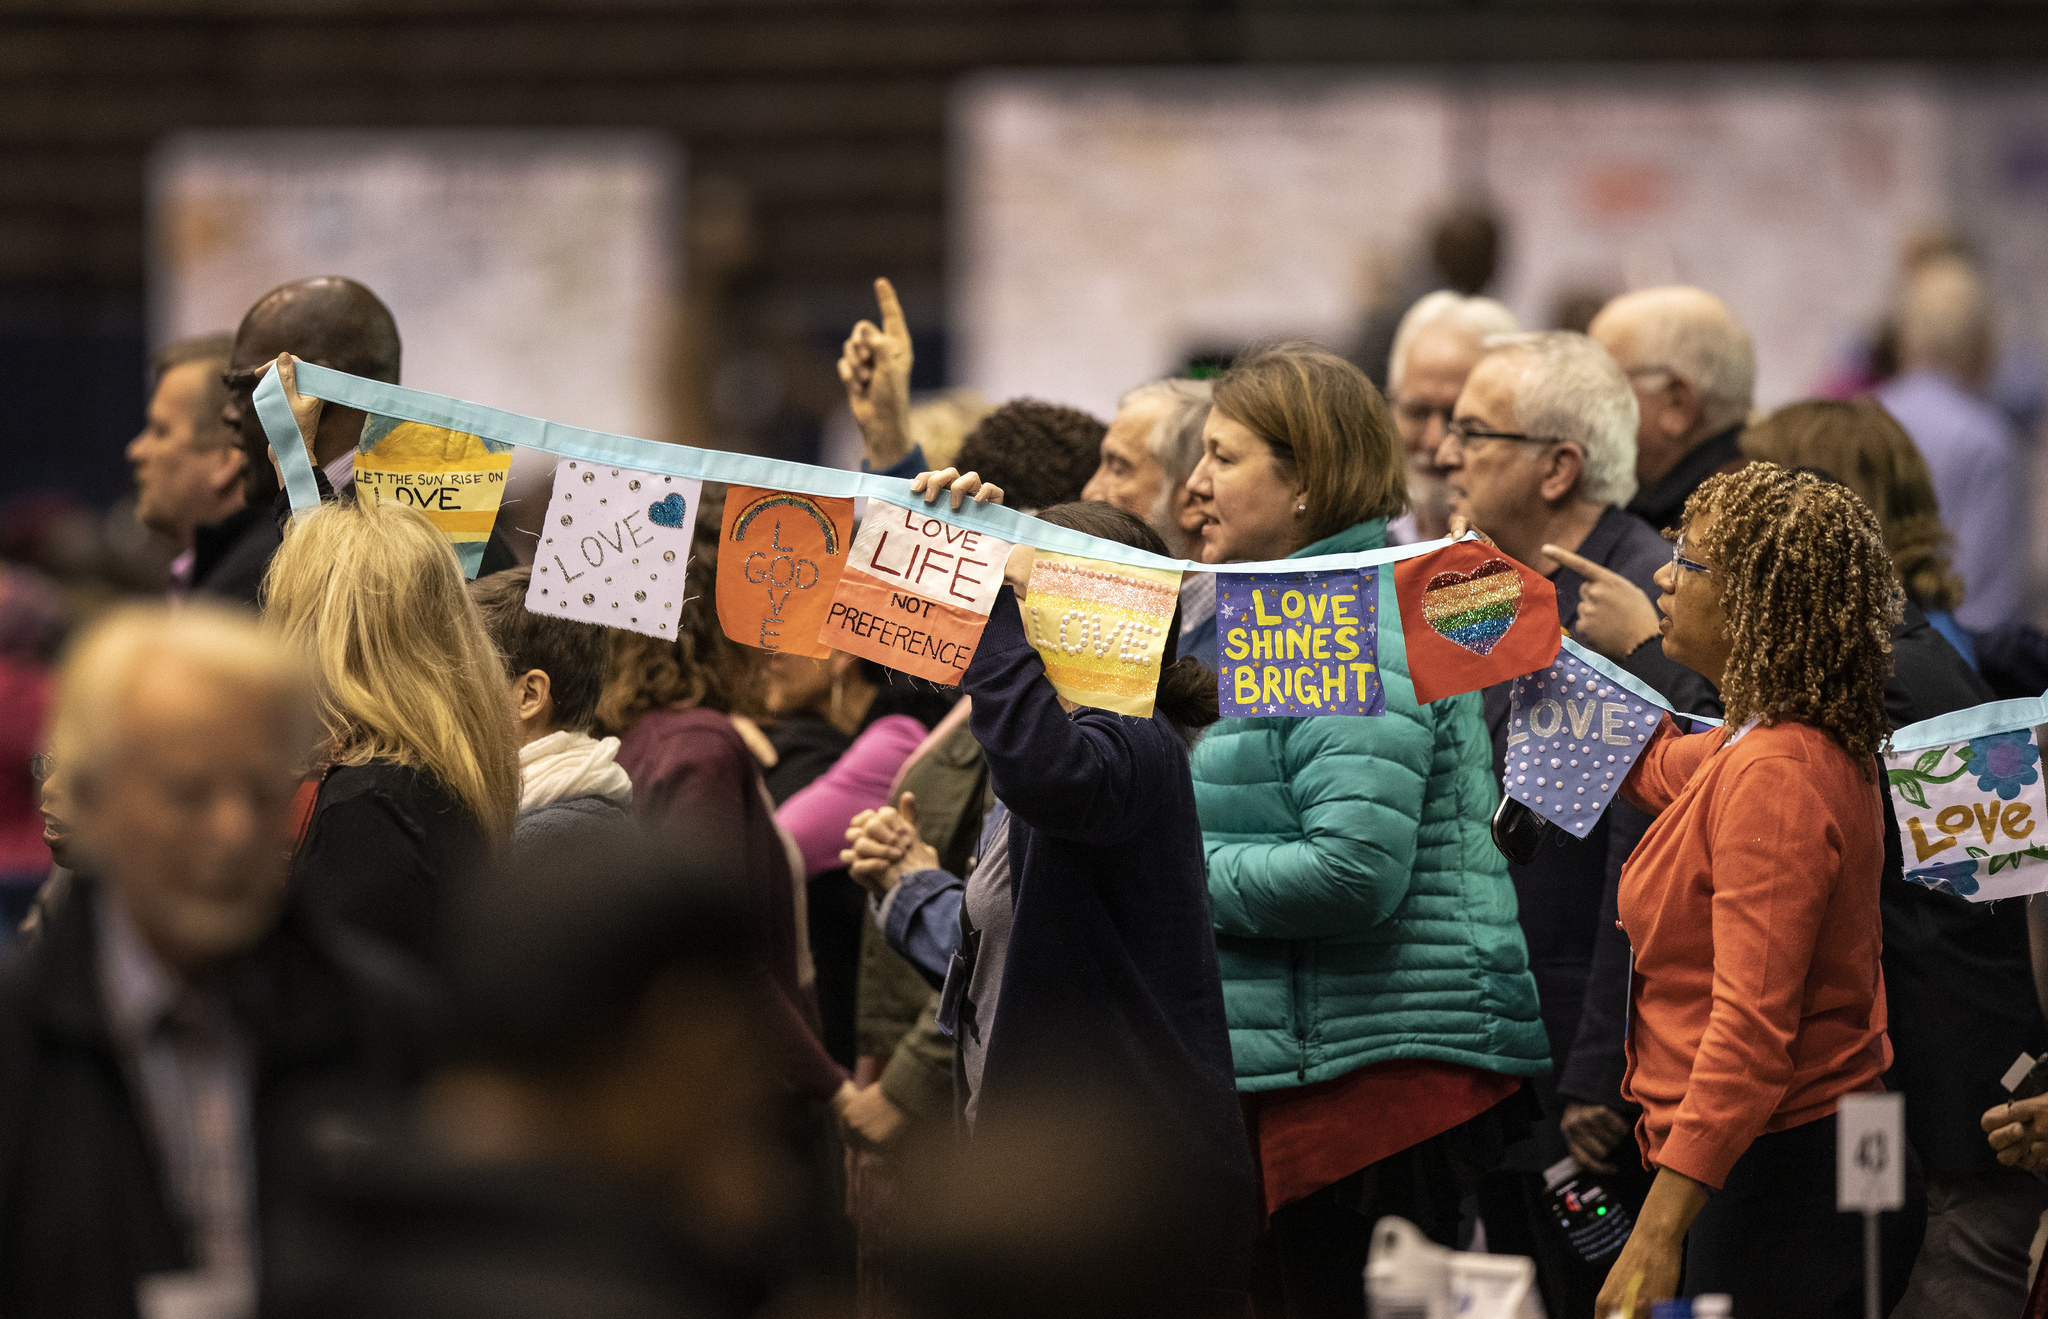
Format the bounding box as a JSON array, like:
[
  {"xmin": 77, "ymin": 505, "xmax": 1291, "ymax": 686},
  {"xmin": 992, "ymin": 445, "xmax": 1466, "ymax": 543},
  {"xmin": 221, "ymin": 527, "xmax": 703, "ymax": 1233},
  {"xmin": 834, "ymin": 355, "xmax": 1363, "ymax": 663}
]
[{"xmin": 0, "ymin": 879, "xmax": 428, "ymax": 1319}]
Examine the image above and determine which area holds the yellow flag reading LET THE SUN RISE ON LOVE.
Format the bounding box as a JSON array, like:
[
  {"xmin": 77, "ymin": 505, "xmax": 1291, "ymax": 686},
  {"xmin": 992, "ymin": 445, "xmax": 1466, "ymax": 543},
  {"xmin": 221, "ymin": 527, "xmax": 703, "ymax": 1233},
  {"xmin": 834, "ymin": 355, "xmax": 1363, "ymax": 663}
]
[{"xmin": 356, "ymin": 416, "xmax": 512, "ymax": 578}]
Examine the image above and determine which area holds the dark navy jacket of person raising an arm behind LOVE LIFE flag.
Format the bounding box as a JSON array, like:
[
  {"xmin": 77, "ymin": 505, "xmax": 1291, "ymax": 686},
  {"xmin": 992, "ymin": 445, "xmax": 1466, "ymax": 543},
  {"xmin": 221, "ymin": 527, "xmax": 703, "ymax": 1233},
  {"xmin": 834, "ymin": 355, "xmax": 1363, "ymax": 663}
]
[{"xmin": 961, "ymin": 602, "xmax": 1255, "ymax": 1292}]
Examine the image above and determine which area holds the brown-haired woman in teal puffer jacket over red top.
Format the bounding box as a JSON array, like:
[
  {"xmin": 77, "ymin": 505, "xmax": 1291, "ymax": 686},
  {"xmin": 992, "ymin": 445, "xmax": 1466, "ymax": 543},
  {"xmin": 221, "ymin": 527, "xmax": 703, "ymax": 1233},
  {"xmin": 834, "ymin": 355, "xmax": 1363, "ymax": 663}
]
[{"xmin": 1188, "ymin": 344, "xmax": 1550, "ymax": 1317}]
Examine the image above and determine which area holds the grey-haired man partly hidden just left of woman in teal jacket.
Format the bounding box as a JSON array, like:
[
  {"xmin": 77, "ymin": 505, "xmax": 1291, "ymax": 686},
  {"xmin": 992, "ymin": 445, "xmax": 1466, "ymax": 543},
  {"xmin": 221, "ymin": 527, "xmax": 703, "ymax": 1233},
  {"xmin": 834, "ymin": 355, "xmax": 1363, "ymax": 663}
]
[{"xmin": 1081, "ymin": 379, "xmax": 1217, "ymax": 668}]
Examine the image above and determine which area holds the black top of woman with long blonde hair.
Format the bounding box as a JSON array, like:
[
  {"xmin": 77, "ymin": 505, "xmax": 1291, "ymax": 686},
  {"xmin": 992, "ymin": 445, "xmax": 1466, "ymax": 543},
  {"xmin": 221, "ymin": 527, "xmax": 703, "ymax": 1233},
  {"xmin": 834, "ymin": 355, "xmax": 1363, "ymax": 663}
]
[{"xmin": 291, "ymin": 760, "xmax": 489, "ymax": 961}]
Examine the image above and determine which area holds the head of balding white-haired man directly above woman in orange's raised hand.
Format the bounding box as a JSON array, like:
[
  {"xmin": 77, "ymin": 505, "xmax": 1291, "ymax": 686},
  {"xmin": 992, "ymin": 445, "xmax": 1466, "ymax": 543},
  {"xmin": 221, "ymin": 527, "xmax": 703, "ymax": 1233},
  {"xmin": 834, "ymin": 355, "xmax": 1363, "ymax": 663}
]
[{"xmin": 1587, "ymin": 287, "xmax": 1757, "ymax": 530}]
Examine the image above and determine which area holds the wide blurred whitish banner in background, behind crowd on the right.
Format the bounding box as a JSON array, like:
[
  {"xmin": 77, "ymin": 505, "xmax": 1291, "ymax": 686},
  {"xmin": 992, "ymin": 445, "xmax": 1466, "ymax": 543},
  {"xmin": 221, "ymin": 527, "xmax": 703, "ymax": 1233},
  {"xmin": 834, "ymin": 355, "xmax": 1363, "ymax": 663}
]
[{"xmin": 952, "ymin": 66, "xmax": 2048, "ymax": 412}]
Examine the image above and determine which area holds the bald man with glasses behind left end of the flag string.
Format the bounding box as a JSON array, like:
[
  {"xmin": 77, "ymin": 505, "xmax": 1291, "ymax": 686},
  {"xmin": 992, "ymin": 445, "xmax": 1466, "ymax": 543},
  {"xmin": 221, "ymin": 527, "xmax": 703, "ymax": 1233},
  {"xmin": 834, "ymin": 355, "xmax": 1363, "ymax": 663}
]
[{"xmin": 193, "ymin": 274, "xmax": 518, "ymax": 606}]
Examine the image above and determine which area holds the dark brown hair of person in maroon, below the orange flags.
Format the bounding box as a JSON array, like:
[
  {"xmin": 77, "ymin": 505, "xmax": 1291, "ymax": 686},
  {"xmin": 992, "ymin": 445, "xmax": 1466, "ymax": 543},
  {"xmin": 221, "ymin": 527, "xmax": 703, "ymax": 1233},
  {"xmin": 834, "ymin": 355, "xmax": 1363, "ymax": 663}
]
[{"xmin": 598, "ymin": 485, "xmax": 762, "ymax": 737}]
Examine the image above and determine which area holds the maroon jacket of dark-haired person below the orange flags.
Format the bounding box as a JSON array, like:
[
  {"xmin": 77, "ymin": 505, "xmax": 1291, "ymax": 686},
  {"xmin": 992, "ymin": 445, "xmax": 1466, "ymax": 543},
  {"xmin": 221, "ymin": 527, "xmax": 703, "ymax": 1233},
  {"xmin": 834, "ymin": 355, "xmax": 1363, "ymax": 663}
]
[{"xmin": 618, "ymin": 709, "xmax": 846, "ymax": 1098}]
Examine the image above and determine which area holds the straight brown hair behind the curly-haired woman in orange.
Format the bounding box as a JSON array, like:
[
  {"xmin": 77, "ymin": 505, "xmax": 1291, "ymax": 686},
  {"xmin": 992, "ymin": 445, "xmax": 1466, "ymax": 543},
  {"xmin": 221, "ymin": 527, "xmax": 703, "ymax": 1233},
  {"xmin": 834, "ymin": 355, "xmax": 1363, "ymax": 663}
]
[{"xmin": 1743, "ymin": 397, "xmax": 1962, "ymax": 610}]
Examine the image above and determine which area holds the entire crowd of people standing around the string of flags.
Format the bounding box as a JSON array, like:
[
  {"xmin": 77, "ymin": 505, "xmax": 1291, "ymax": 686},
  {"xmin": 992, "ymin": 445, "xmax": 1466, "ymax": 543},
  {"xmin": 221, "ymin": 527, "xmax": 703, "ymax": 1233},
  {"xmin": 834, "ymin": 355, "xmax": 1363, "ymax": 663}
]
[{"xmin": 0, "ymin": 213, "xmax": 2048, "ymax": 1319}]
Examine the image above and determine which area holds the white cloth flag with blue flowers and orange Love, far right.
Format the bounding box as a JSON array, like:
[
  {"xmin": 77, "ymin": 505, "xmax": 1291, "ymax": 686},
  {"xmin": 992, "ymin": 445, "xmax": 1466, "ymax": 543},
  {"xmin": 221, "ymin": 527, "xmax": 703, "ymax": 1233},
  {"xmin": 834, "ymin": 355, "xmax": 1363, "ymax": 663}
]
[{"xmin": 1884, "ymin": 727, "xmax": 2048, "ymax": 901}]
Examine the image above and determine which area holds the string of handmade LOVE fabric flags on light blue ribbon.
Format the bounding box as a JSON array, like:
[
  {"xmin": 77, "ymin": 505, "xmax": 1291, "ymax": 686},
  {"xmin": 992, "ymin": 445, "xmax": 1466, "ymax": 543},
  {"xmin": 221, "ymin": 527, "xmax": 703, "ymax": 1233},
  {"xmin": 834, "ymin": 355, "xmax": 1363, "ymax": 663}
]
[{"xmin": 254, "ymin": 363, "xmax": 2048, "ymax": 901}]
